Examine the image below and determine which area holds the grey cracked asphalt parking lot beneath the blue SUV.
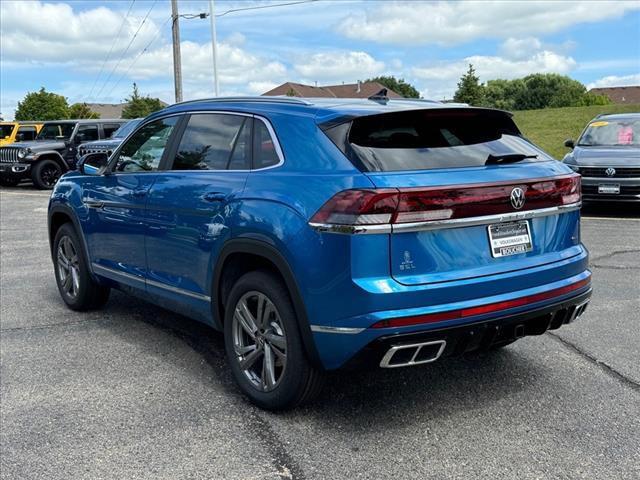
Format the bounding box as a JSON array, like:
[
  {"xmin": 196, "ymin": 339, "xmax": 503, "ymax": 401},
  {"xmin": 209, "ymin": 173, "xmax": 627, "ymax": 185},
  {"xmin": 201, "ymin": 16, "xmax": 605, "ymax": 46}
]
[{"xmin": 0, "ymin": 187, "xmax": 640, "ymax": 479}]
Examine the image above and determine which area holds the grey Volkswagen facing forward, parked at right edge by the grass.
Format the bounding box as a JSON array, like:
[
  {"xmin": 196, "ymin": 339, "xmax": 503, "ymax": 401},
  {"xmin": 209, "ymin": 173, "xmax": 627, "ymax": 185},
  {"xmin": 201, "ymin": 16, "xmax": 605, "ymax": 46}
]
[{"xmin": 563, "ymin": 113, "xmax": 640, "ymax": 202}]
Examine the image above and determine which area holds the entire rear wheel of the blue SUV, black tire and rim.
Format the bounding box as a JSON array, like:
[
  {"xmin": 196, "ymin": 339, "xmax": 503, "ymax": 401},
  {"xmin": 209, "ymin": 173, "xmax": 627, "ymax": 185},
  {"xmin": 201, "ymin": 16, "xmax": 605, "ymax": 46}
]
[{"xmin": 224, "ymin": 271, "xmax": 323, "ymax": 410}]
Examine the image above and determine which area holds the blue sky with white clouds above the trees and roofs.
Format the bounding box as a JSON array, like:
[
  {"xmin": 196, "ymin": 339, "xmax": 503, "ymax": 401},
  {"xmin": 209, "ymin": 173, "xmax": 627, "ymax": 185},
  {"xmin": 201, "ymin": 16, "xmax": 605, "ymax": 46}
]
[{"xmin": 0, "ymin": 0, "xmax": 640, "ymax": 119}]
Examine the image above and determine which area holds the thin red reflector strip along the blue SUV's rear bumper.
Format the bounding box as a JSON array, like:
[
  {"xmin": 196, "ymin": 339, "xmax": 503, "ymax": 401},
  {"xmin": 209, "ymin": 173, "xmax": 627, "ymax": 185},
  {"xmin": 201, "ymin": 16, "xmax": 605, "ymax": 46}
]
[{"xmin": 371, "ymin": 277, "xmax": 591, "ymax": 328}]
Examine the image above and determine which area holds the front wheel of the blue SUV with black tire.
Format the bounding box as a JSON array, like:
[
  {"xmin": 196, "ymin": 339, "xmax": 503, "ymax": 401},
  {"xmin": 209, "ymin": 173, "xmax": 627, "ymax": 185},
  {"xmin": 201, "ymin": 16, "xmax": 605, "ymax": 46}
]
[{"xmin": 53, "ymin": 223, "xmax": 111, "ymax": 311}]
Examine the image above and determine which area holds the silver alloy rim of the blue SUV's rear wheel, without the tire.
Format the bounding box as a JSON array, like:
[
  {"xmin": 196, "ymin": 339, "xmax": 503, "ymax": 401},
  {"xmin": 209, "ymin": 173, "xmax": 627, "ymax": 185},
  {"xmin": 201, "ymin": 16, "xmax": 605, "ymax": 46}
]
[{"xmin": 232, "ymin": 291, "xmax": 287, "ymax": 392}]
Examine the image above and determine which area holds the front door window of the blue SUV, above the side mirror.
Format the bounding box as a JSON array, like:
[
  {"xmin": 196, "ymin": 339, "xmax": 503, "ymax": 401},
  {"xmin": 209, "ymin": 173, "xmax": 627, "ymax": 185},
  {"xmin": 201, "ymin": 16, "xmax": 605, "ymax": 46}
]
[{"xmin": 114, "ymin": 117, "xmax": 178, "ymax": 172}]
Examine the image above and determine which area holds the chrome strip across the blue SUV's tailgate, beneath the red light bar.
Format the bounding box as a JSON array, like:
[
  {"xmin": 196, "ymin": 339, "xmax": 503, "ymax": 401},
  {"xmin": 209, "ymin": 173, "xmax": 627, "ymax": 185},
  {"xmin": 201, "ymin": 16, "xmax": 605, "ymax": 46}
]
[{"xmin": 309, "ymin": 202, "xmax": 582, "ymax": 234}]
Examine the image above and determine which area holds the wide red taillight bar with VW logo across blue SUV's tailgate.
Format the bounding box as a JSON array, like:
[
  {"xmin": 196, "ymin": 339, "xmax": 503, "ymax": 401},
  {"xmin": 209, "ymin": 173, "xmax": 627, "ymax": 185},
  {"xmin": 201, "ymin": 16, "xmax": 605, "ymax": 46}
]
[{"xmin": 310, "ymin": 174, "xmax": 580, "ymax": 226}]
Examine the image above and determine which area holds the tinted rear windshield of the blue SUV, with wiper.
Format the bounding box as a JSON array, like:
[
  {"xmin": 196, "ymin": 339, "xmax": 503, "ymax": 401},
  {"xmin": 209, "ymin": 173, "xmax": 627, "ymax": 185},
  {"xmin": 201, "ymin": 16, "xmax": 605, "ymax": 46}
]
[{"xmin": 326, "ymin": 109, "xmax": 551, "ymax": 172}]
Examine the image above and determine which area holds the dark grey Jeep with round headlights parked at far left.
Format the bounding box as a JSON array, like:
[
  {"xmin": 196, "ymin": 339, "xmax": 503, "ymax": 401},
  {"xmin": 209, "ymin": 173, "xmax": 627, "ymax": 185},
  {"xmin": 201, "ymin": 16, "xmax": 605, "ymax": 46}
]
[{"xmin": 0, "ymin": 119, "xmax": 126, "ymax": 189}]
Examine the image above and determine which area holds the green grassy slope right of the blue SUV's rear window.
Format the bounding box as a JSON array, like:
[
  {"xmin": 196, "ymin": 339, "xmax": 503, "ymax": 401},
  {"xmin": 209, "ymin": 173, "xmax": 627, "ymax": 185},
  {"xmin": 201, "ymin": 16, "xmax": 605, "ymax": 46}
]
[{"xmin": 513, "ymin": 105, "xmax": 640, "ymax": 160}]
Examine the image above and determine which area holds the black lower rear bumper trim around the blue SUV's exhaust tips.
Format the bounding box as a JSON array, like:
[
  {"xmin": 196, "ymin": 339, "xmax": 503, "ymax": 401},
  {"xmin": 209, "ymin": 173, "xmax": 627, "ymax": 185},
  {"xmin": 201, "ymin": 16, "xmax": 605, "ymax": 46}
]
[{"xmin": 343, "ymin": 288, "xmax": 592, "ymax": 369}]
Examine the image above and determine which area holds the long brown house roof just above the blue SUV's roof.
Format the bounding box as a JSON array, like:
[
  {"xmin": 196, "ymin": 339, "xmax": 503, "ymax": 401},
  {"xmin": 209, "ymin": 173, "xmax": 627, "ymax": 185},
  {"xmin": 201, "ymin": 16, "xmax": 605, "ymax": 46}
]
[{"xmin": 262, "ymin": 82, "xmax": 403, "ymax": 98}]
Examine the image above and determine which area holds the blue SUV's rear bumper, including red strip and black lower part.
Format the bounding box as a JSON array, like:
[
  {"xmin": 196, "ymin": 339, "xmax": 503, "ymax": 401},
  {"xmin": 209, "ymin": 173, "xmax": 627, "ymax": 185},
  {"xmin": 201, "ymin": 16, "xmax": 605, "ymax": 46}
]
[{"xmin": 311, "ymin": 270, "xmax": 591, "ymax": 370}]
